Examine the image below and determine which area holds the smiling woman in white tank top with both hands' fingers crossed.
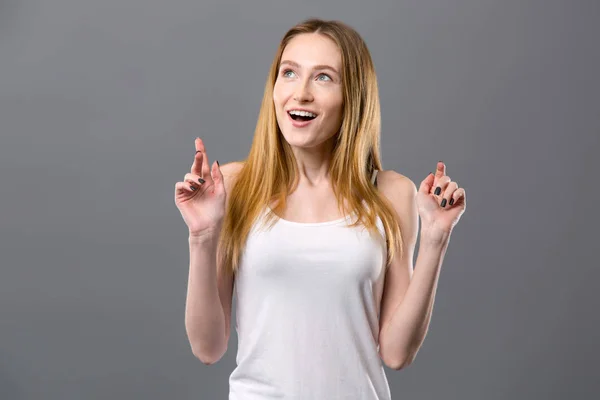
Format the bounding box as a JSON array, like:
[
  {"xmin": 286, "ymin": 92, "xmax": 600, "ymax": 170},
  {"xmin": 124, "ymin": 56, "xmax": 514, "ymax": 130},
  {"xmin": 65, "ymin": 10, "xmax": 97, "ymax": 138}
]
[{"xmin": 175, "ymin": 19, "xmax": 466, "ymax": 400}]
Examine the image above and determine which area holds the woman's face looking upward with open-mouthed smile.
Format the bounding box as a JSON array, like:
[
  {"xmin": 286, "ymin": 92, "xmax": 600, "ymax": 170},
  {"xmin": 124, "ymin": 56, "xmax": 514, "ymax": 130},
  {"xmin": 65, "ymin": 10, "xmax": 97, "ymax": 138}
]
[{"xmin": 273, "ymin": 33, "xmax": 343, "ymax": 147}]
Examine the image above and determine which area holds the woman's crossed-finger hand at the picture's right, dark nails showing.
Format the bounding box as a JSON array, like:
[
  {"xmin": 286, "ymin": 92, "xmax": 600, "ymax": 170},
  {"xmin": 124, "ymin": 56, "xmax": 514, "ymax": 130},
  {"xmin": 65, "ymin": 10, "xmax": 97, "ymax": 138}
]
[{"xmin": 416, "ymin": 161, "xmax": 467, "ymax": 242}]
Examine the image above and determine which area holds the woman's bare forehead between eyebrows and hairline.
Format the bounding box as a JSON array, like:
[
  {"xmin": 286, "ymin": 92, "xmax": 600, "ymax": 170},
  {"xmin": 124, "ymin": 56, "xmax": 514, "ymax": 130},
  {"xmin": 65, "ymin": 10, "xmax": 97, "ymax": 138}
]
[{"xmin": 281, "ymin": 33, "xmax": 342, "ymax": 71}]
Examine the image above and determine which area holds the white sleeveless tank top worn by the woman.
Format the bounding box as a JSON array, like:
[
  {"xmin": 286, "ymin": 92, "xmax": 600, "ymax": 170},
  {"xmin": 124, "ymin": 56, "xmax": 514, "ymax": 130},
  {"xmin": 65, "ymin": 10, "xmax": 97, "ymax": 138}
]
[{"xmin": 229, "ymin": 171, "xmax": 391, "ymax": 400}]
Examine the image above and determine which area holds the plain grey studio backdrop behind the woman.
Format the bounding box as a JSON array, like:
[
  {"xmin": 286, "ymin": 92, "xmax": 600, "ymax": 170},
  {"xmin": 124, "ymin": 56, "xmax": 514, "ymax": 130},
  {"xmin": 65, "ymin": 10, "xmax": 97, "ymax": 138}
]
[{"xmin": 0, "ymin": 0, "xmax": 600, "ymax": 400}]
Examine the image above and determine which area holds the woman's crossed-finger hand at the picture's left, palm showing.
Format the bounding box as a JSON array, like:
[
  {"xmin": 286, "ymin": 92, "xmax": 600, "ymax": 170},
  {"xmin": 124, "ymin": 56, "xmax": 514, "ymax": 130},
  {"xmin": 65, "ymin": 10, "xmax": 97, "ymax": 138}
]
[{"xmin": 175, "ymin": 138, "xmax": 227, "ymax": 236}]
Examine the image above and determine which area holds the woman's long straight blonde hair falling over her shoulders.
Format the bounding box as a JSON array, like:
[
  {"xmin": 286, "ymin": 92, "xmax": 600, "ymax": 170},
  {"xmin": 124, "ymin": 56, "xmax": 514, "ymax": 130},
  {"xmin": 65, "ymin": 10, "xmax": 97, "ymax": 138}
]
[{"xmin": 218, "ymin": 18, "xmax": 403, "ymax": 275}]
